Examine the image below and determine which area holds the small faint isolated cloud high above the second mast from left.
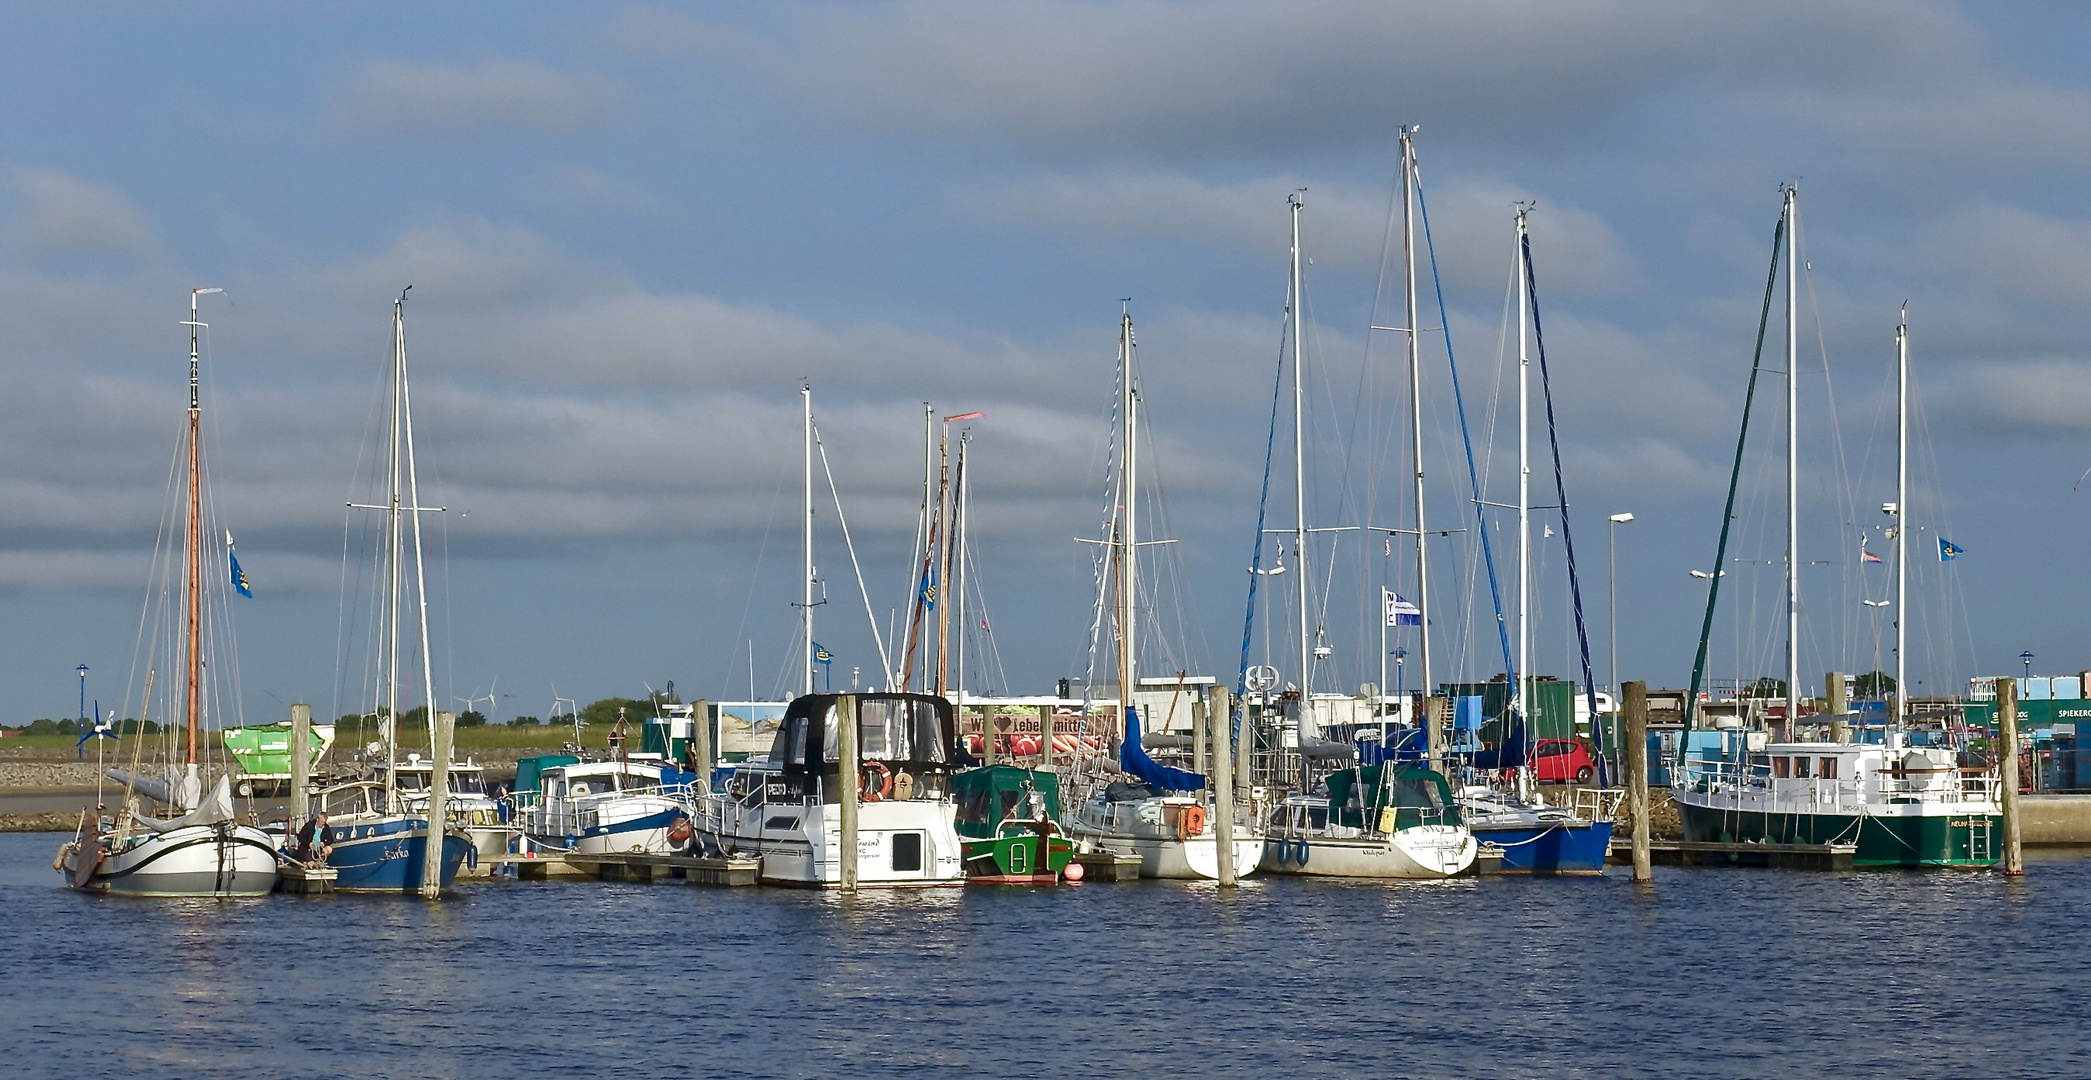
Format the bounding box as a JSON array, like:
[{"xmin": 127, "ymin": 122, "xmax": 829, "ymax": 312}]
[{"xmin": 328, "ymin": 59, "xmax": 625, "ymax": 138}]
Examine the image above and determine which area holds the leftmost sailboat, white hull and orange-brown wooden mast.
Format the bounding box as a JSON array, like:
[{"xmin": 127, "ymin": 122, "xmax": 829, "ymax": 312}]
[{"xmin": 52, "ymin": 289, "xmax": 278, "ymax": 896}]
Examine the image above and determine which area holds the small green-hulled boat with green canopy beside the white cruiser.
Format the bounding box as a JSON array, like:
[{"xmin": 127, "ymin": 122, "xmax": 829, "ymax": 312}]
[{"xmin": 951, "ymin": 764, "xmax": 1075, "ymax": 885}]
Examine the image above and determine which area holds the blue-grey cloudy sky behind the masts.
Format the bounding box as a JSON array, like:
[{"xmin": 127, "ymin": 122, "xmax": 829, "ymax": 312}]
[{"xmin": 0, "ymin": 0, "xmax": 2091, "ymax": 724}]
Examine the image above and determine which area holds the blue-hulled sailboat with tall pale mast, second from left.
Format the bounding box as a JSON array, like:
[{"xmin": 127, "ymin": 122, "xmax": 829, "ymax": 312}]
[{"xmin": 307, "ymin": 293, "xmax": 475, "ymax": 894}]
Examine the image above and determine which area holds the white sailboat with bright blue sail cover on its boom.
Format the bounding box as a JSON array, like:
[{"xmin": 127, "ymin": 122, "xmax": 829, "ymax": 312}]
[{"xmin": 1069, "ymin": 310, "xmax": 1263, "ymax": 879}]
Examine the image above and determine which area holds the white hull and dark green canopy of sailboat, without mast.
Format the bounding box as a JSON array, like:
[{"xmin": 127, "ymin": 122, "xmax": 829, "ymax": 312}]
[{"xmin": 1265, "ymin": 762, "xmax": 1478, "ymax": 879}]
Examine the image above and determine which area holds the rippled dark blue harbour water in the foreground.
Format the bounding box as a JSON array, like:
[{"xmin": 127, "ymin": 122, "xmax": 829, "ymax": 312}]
[{"xmin": 0, "ymin": 835, "xmax": 2091, "ymax": 1080}]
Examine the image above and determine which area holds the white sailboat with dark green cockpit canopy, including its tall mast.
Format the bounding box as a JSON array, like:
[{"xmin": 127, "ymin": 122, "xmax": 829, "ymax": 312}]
[{"xmin": 1265, "ymin": 191, "xmax": 1476, "ymax": 879}]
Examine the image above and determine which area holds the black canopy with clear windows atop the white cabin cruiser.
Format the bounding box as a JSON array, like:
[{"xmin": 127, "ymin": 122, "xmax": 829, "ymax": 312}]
[{"xmin": 769, "ymin": 693, "xmax": 958, "ymax": 777}]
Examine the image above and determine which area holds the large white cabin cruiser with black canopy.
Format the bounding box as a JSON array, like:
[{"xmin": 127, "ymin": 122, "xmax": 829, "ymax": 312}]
[{"xmin": 696, "ymin": 693, "xmax": 966, "ymax": 887}]
